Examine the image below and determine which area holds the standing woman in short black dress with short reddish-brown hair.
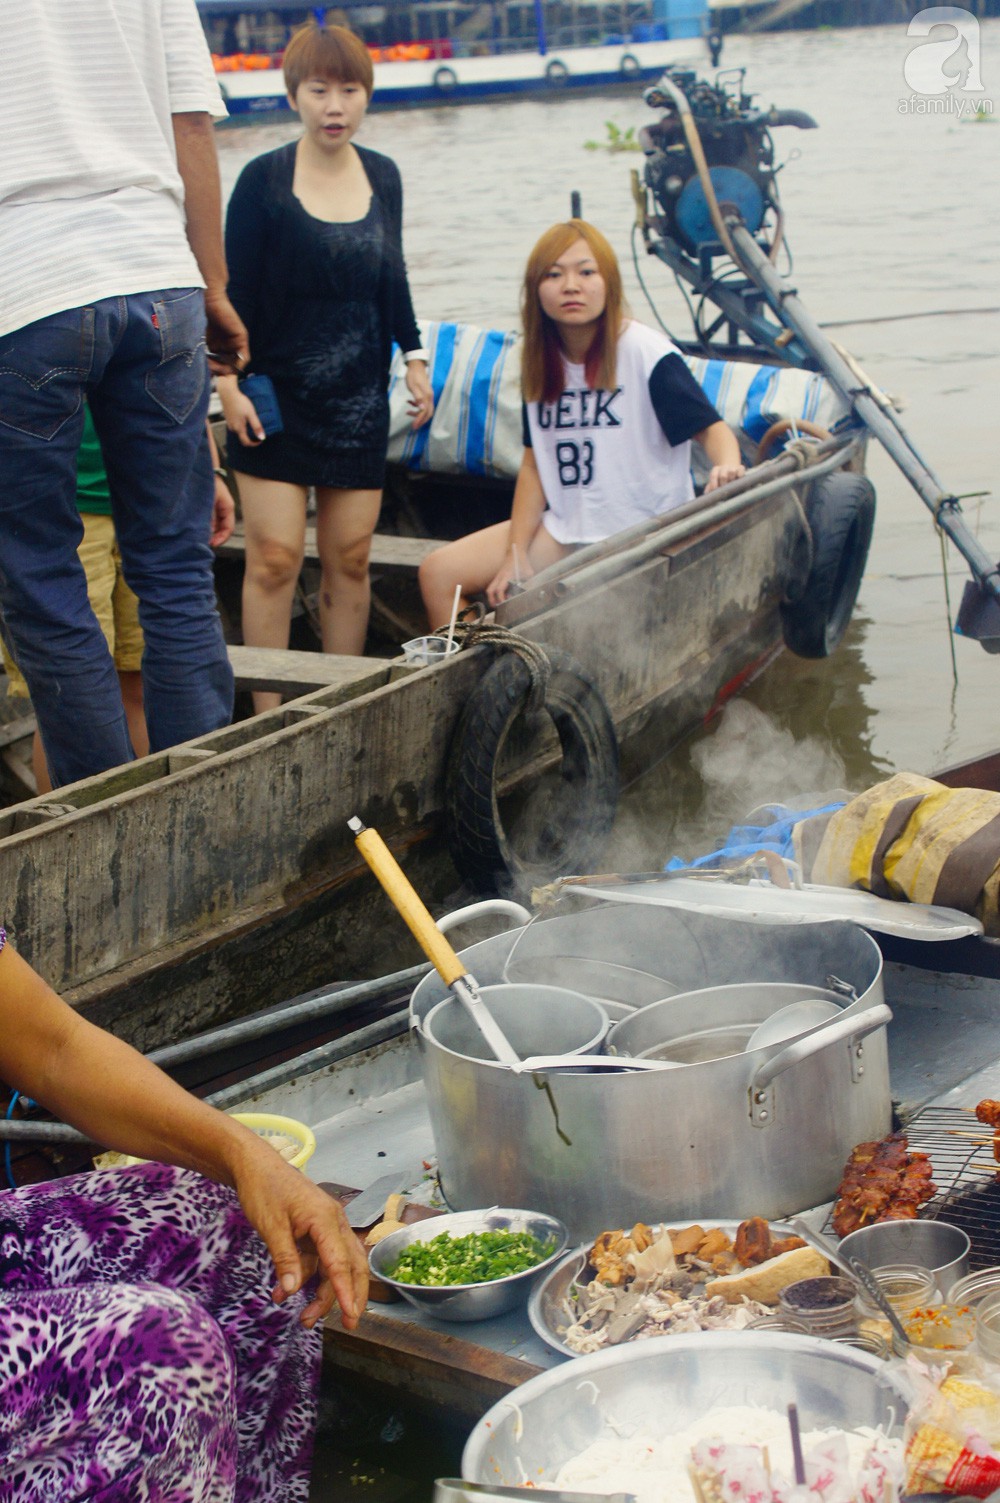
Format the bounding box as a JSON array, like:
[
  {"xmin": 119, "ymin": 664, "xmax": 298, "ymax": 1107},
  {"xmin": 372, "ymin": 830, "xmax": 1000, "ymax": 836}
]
[{"xmin": 218, "ymin": 24, "xmax": 435, "ymax": 711}]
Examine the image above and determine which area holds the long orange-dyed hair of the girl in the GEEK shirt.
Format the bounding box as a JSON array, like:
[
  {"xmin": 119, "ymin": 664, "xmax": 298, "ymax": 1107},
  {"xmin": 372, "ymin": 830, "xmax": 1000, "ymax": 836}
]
[{"xmin": 520, "ymin": 219, "xmax": 627, "ymax": 401}]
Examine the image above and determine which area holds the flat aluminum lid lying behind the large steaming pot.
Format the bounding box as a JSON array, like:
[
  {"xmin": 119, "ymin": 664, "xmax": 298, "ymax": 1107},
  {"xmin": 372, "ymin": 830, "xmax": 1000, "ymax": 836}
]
[{"xmin": 568, "ymin": 876, "xmax": 983, "ymax": 939}]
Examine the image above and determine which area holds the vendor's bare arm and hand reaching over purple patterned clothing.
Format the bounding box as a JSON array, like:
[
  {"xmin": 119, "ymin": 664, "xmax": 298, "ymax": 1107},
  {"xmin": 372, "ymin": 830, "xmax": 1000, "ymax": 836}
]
[{"xmin": 0, "ymin": 944, "xmax": 368, "ymax": 1327}]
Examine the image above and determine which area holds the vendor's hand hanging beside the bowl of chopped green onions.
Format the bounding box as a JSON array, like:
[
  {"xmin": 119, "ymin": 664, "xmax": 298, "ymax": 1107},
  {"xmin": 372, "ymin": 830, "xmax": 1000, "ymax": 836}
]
[{"xmin": 235, "ymin": 1135, "xmax": 368, "ymax": 1330}]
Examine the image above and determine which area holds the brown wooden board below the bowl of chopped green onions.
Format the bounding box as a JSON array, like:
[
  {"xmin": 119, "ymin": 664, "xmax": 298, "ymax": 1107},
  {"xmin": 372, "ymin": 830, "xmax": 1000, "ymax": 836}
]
[{"xmin": 323, "ymin": 1309, "xmax": 543, "ymax": 1419}]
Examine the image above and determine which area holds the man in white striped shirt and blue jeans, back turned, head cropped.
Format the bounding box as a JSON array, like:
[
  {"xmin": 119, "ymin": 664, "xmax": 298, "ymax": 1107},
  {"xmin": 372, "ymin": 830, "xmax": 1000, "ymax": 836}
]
[{"xmin": 0, "ymin": 0, "xmax": 248, "ymax": 786}]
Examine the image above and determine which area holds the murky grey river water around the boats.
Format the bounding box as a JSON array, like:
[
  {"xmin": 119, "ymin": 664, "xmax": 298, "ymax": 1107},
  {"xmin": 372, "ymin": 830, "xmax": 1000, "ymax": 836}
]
[{"xmin": 220, "ymin": 21, "xmax": 1000, "ymax": 866}]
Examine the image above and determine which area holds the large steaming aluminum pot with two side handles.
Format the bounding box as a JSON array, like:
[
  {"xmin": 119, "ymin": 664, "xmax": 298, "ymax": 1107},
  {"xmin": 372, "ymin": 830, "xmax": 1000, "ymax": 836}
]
[{"xmin": 411, "ymin": 905, "xmax": 890, "ymax": 1241}]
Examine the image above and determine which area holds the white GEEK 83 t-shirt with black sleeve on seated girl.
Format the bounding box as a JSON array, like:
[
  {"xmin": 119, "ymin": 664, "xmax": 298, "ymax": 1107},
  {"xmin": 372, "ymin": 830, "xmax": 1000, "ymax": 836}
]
[{"xmin": 525, "ymin": 322, "xmax": 719, "ymax": 543}]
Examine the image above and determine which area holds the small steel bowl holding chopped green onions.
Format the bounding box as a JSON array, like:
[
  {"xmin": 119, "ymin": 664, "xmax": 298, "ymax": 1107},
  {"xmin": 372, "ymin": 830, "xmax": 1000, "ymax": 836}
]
[{"xmin": 368, "ymin": 1205, "xmax": 567, "ymax": 1320}]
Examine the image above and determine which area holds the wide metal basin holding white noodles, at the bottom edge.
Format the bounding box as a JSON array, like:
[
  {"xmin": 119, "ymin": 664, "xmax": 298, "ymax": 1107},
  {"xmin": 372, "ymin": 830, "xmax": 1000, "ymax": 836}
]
[{"xmin": 462, "ymin": 1332, "xmax": 908, "ymax": 1497}]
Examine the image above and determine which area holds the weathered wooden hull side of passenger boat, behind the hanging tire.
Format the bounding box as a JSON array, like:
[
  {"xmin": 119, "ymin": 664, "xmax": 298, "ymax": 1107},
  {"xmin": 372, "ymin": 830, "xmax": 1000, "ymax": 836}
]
[{"xmin": 0, "ymin": 491, "xmax": 800, "ymax": 1049}]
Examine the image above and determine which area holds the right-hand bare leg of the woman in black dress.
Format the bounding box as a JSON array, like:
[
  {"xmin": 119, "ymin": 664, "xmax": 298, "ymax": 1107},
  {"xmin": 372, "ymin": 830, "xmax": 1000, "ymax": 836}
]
[{"xmin": 316, "ymin": 487, "xmax": 382, "ymax": 657}]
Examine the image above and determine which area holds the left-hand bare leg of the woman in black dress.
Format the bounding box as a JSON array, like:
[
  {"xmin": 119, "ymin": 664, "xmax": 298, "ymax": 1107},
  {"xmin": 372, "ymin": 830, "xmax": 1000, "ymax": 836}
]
[{"xmin": 236, "ymin": 473, "xmax": 305, "ymax": 715}]
